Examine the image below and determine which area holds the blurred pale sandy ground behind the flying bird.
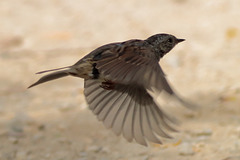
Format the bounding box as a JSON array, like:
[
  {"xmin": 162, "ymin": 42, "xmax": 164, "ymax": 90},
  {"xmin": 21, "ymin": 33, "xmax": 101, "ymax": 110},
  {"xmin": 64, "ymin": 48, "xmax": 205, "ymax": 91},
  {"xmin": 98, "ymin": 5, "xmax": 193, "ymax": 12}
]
[{"xmin": 0, "ymin": 0, "xmax": 240, "ymax": 160}]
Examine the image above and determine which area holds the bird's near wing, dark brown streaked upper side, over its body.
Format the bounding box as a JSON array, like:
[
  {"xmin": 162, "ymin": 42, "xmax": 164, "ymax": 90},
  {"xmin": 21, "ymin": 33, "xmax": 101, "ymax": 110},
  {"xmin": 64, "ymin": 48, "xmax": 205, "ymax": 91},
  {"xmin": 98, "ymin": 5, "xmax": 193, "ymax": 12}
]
[{"xmin": 87, "ymin": 40, "xmax": 173, "ymax": 94}]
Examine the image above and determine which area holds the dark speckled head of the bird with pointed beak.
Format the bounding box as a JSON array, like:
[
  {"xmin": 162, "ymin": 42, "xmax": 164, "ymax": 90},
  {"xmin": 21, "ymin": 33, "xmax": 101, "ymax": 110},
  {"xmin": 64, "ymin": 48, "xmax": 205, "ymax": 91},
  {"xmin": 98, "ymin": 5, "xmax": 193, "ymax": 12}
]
[{"xmin": 146, "ymin": 33, "xmax": 185, "ymax": 59}]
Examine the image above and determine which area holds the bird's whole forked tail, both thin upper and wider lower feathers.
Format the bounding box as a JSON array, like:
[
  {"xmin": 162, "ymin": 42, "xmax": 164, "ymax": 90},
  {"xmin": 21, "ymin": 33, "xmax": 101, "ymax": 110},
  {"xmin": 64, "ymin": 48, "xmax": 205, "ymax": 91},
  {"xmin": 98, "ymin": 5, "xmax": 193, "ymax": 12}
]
[{"xmin": 28, "ymin": 67, "xmax": 69, "ymax": 88}]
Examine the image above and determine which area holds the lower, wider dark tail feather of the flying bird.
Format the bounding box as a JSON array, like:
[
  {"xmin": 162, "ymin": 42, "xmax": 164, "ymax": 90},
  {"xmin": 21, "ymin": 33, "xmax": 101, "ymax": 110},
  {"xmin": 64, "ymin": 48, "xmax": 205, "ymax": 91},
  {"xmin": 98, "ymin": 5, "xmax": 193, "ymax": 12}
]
[{"xmin": 28, "ymin": 70, "xmax": 69, "ymax": 88}]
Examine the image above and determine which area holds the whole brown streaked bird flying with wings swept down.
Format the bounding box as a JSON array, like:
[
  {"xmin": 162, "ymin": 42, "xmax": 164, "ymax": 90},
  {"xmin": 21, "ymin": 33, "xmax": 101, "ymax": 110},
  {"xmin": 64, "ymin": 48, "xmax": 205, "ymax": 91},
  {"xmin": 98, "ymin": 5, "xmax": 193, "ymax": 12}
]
[{"xmin": 28, "ymin": 33, "xmax": 192, "ymax": 146}]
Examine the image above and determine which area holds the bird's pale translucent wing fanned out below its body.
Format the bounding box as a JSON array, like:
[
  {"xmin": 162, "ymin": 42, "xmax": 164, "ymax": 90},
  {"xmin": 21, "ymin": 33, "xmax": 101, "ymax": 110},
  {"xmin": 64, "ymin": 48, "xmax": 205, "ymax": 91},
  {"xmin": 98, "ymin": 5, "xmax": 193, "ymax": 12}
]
[{"xmin": 84, "ymin": 80, "xmax": 176, "ymax": 145}]
